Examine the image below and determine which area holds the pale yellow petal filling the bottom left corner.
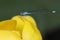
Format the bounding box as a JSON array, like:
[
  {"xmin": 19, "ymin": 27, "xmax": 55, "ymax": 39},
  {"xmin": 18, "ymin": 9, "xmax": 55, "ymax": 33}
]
[{"xmin": 0, "ymin": 30, "xmax": 21, "ymax": 40}]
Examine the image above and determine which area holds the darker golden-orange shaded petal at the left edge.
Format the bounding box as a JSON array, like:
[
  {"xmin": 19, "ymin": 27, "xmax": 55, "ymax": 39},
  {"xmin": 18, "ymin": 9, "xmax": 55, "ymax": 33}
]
[{"xmin": 0, "ymin": 20, "xmax": 16, "ymax": 30}]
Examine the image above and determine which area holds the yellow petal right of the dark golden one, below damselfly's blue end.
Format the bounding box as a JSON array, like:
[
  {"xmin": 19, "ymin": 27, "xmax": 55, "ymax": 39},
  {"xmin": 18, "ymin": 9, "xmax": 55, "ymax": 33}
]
[{"xmin": 12, "ymin": 15, "xmax": 24, "ymax": 31}]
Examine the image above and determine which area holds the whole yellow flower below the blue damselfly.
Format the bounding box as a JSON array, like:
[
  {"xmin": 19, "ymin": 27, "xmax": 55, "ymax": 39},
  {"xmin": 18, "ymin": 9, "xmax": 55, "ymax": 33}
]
[{"xmin": 0, "ymin": 15, "xmax": 42, "ymax": 40}]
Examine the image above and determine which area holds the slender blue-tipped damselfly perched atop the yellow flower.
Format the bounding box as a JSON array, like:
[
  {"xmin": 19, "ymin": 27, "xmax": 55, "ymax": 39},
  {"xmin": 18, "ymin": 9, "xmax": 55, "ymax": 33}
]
[{"xmin": 20, "ymin": 9, "xmax": 56, "ymax": 15}]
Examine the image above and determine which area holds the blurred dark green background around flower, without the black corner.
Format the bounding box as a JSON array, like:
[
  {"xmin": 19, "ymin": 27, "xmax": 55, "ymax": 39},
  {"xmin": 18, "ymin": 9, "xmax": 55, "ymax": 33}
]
[{"xmin": 0, "ymin": 0, "xmax": 60, "ymax": 35}]
